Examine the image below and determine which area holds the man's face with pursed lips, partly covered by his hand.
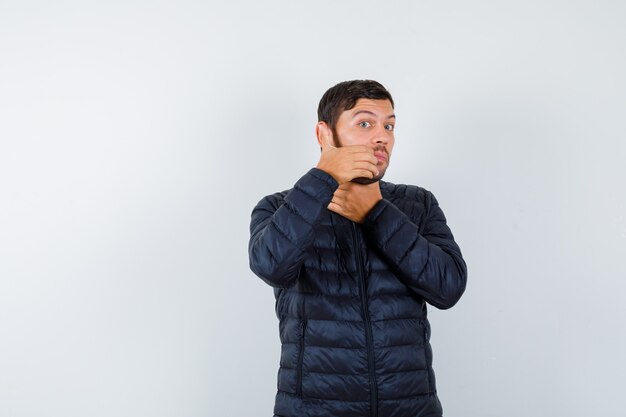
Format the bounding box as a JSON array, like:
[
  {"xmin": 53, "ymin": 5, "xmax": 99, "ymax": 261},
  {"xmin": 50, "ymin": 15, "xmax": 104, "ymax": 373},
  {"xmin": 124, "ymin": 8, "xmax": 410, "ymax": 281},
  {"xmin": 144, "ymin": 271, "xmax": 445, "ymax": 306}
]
[{"xmin": 333, "ymin": 98, "xmax": 396, "ymax": 184}]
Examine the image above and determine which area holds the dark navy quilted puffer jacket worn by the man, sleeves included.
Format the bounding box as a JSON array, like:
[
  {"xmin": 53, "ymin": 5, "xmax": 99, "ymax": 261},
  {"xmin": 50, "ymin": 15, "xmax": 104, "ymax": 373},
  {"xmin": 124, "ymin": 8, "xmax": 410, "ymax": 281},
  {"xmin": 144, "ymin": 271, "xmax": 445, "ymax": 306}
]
[{"xmin": 249, "ymin": 168, "xmax": 467, "ymax": 417}]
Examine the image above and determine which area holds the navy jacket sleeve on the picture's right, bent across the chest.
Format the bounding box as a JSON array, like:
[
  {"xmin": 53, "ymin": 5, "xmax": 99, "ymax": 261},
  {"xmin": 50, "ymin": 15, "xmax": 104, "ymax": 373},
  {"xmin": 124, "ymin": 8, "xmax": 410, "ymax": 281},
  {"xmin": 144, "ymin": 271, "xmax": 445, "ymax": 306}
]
[{"xmin": 364, "ymin": 192, "xmax": 467, "ymax": 309}]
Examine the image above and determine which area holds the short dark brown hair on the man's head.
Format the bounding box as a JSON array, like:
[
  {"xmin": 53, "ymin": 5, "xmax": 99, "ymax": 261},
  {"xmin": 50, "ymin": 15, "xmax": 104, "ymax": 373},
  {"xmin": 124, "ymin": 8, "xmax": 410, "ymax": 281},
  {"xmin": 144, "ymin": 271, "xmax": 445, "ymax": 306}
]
[{"xmin": 317, "ymin": 80, "xmax": 394, "ymax": 129}]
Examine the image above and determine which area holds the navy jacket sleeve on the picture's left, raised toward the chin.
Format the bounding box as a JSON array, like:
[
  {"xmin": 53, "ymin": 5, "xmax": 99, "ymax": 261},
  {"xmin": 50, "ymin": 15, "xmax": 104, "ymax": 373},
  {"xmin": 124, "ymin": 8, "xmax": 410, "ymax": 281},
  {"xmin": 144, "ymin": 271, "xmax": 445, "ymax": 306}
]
[{"xmin": 248, "ymin": 168, "xmax": 338, "ymax": 288}]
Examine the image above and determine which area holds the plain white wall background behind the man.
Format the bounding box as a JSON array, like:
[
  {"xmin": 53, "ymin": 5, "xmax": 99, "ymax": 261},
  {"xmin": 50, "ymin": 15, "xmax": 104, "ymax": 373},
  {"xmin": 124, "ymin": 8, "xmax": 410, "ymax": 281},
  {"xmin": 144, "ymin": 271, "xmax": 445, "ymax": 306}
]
[{"xmin": 0, "ymin": 0, "xmax": 626, "ymax": 417}]
